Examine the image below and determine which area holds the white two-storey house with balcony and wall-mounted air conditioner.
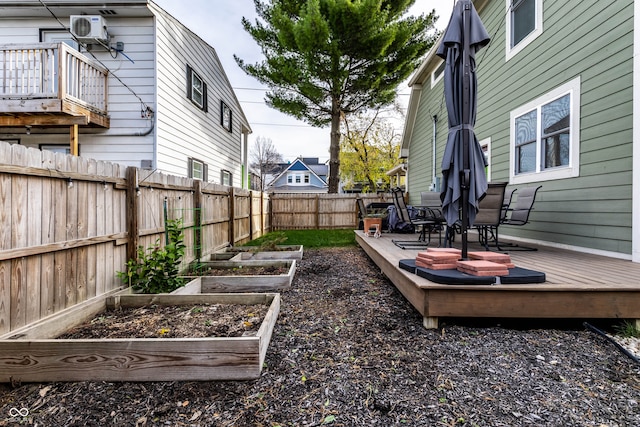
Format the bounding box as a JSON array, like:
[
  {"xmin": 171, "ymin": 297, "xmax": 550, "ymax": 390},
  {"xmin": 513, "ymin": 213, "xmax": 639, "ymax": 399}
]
[{"xmin": 0, "ymin": 0, "xmax": 251, "ymax": 188}]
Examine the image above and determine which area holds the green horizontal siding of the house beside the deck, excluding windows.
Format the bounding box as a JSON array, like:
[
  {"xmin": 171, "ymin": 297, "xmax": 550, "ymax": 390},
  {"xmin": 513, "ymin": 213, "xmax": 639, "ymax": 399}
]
[{"xmin": 409, "ymin": 0, "xmax": 633, "ymax": 256}]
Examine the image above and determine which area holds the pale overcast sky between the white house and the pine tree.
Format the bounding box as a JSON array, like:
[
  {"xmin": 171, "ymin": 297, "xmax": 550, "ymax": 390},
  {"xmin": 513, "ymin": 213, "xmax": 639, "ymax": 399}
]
[{"xmin": 154, "ymin": 0, "xmax": 454, "ymax": 161}]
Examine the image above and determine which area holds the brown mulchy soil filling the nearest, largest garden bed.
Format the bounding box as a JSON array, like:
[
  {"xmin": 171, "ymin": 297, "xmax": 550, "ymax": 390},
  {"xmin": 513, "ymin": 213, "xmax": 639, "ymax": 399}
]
[{"xmin": 58, "ymin": 304, "xmax": 269, "ymax": 339}]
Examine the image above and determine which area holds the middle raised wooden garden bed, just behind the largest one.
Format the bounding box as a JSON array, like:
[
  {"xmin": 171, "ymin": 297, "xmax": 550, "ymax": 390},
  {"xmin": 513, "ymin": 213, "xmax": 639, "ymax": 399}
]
[{"xmin": 183, "ymin": 260, "xmax": 296, "ymax": 293}]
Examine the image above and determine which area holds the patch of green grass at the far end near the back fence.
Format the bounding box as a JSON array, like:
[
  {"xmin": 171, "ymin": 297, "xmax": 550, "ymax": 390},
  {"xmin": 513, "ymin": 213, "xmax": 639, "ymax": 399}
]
[{"xmin": 245, "ymin": 229, "xmax": 357, "ymax": 249}]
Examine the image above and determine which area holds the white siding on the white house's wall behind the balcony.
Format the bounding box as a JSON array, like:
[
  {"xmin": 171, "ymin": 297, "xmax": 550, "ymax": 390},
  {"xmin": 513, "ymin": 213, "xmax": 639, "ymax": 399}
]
[{"xmin": 0, "ymin": 17, "xmax": 155, "ymax": 167}]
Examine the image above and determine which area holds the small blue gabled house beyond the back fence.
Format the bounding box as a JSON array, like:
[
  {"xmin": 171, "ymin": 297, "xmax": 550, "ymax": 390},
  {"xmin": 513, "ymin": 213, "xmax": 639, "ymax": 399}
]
[{"xmin": 266, "ymin": 157, "xmax": 329, "ymax": 193}]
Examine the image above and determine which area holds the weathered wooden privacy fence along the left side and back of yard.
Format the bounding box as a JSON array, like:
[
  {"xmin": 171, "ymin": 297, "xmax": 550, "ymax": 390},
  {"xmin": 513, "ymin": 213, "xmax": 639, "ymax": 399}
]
[{"xmin": 0, "ymin": 142, "xmax": 390, "ymax": 335}]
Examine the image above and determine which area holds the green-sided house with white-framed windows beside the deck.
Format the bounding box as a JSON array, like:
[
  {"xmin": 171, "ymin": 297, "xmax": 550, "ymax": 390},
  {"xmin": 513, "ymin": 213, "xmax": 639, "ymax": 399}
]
[{"xmin": 401, "ymin": 0, "xmax": 640, "ymax": 262}]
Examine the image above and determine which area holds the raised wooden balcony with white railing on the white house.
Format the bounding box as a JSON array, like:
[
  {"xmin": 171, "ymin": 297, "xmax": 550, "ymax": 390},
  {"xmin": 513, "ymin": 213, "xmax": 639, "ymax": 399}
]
[{"xmin": 0, "ymin": 43, "xmax": 110, "ymax": 128}]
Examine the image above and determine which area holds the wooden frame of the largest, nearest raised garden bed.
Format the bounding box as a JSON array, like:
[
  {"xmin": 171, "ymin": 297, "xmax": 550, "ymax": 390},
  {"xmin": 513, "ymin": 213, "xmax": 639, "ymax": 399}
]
[{"xmin": 0, "ymin": 293, "xmax": 280, "ymax": 383}]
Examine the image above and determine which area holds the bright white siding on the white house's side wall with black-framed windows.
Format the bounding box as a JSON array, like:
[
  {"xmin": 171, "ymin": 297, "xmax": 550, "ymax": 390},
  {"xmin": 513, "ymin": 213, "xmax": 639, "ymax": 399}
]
[{"xmin": 156, "ymin": 4, "xmax": 248, "ymax": 185}]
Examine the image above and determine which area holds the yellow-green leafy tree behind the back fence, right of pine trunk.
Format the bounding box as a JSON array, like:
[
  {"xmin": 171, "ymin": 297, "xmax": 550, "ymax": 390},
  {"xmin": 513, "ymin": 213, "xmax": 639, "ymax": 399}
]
[{"xmin": 340, "ymin": 110, "xmax": 400, "ymax": 193}]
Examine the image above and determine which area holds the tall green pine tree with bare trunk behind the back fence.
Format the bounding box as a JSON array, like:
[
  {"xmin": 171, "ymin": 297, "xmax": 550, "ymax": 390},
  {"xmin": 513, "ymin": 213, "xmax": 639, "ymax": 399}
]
[{"xmin": 235, "ymin": 0, "xmax": 436, "ymax": 193}]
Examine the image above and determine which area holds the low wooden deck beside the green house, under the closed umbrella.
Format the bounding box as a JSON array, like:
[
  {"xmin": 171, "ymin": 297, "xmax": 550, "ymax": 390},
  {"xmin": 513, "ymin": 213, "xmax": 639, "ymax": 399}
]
[{"xmin": 355, "ymin": 231, "xmax": 640, "ymax": 328}]
